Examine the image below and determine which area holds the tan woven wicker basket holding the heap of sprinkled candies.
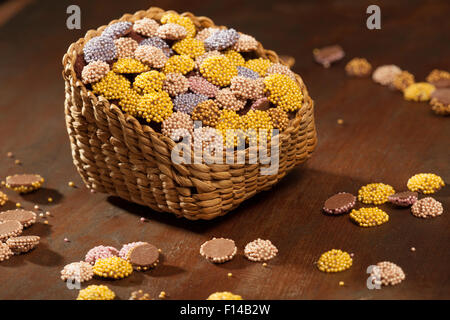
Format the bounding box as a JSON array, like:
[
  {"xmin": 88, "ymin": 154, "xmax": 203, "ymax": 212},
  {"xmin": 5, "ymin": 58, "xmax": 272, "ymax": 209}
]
[{"xmin": 63, "ymin": 7, "xmax": 316, "ymax": 220}]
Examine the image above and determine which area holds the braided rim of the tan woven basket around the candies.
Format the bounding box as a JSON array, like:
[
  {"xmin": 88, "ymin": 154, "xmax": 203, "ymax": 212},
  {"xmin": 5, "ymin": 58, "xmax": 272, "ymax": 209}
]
[{"xmin": 62, "ymin": 7, "xmax": 313, "ymax": 158}]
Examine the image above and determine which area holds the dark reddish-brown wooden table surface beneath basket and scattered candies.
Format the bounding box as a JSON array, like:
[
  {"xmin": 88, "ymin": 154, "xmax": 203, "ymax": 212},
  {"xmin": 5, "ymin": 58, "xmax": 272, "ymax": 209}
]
[{"xmin": 0, "ymin": 0, "xmax": 450, "ymax": 299}]
